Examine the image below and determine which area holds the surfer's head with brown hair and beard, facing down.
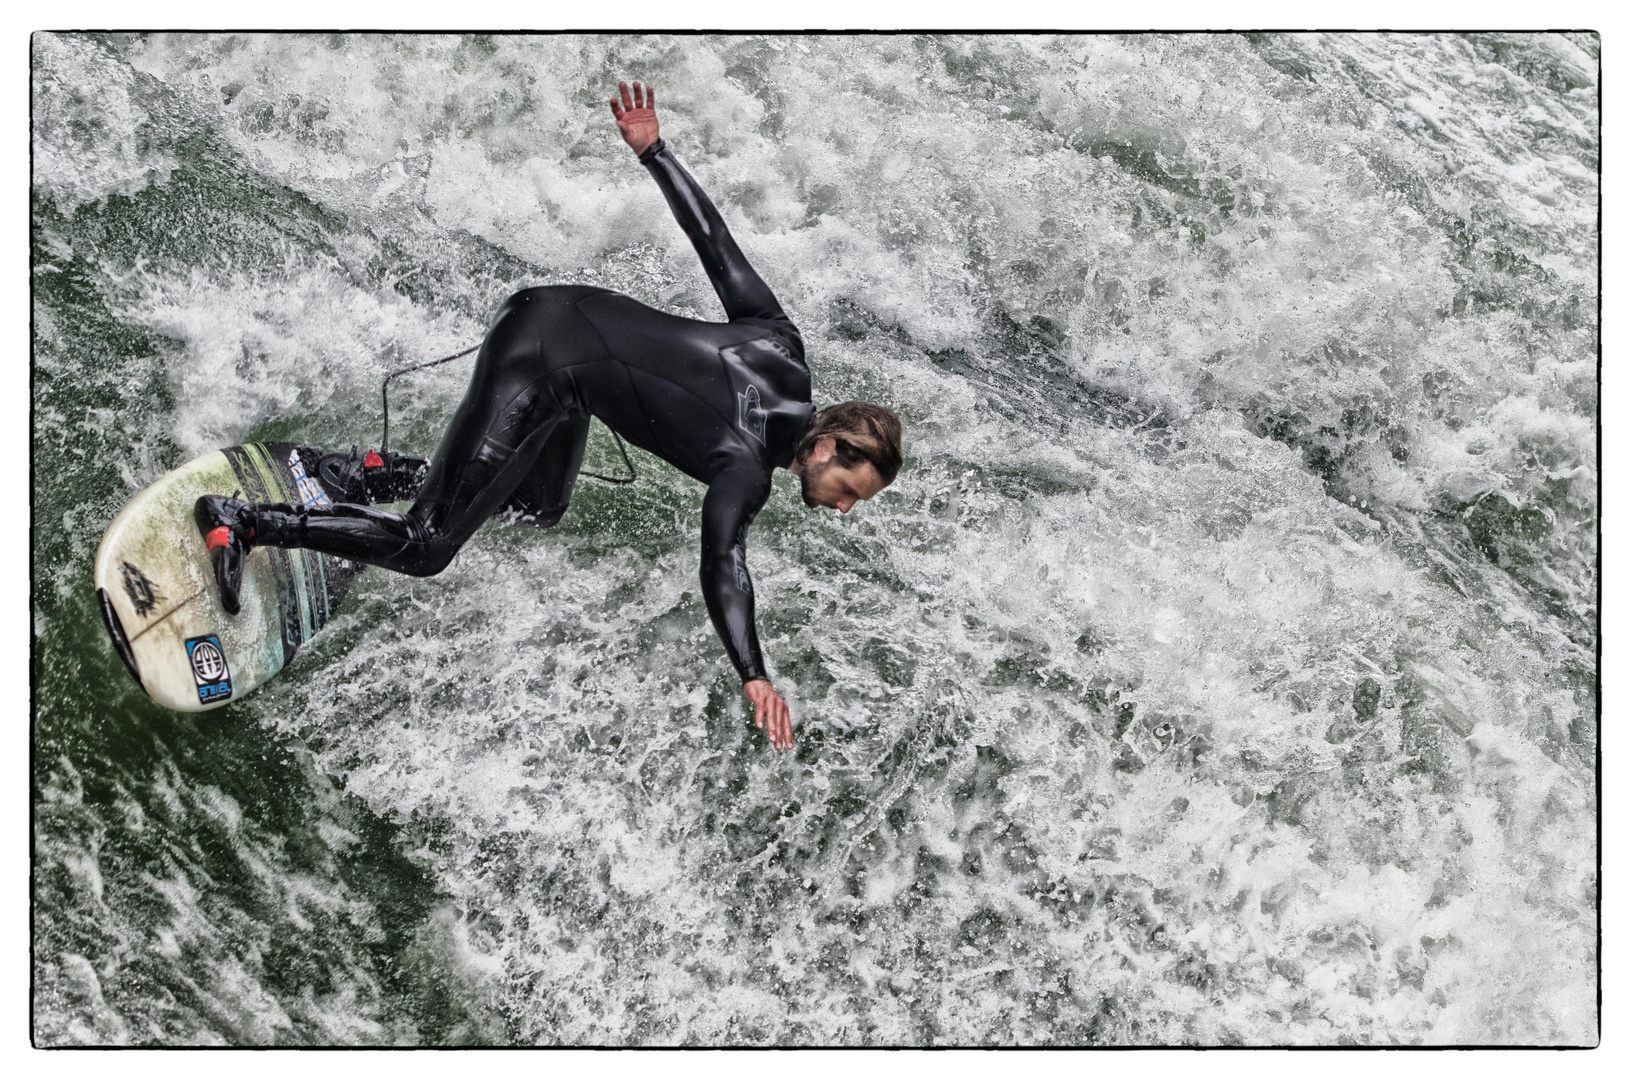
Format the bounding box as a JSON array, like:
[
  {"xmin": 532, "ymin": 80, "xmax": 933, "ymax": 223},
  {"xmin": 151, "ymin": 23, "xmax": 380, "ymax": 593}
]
[{"xmin": 793, "ymin": 401, "xmax": 900, "ymax": 514}]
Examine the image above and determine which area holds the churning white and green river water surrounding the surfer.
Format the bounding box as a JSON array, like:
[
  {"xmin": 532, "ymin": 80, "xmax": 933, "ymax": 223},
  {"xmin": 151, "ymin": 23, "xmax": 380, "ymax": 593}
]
[{"xmin": 33, "ymin": 34, "xmax": 1598, "ymax": 1046}]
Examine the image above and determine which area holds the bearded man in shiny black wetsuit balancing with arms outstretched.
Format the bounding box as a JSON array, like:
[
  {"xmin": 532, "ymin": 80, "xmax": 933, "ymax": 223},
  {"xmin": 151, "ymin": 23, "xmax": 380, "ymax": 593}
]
[{"xmin": 196, "ymin": 83, "xmax": 900, "ymax": 749}]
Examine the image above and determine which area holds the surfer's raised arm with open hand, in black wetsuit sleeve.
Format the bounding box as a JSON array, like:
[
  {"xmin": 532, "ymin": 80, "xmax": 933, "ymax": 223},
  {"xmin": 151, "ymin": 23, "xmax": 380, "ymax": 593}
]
[{"xmin": 612, "ymin": 83, "xmax": 788, "ymax": 320}]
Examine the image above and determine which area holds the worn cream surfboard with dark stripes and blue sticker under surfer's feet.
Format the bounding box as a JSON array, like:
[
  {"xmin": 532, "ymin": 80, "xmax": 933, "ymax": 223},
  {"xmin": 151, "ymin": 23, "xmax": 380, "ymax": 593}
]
[{"xmin": 95, "ymin": 442, "xmax": 362, "ymax": 713}]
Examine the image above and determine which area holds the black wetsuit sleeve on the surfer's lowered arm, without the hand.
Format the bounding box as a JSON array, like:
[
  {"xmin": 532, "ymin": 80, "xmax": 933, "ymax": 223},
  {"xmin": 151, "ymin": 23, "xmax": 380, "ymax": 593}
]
[{"xmin": 701, "ymin": 468, "xmax": 770, "ymax": 682}]
